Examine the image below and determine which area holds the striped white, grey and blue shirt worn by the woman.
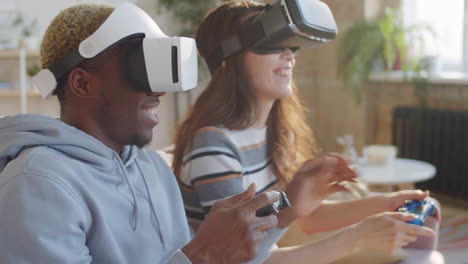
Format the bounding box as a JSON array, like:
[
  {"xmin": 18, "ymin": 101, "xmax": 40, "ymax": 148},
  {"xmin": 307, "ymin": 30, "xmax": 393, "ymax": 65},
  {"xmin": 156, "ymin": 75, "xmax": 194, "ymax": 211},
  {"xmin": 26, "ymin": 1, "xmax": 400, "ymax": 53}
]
[{"xmin": 180, "ymin": 127, "xmax": 277, "ymax": 227}]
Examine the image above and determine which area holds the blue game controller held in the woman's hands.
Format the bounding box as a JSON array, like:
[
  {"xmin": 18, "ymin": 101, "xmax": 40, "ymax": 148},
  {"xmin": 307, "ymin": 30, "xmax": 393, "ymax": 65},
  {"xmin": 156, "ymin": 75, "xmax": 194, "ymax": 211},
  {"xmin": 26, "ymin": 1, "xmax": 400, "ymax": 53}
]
[{"xmin": 397, "ymin": 199, "xmax": 436, "ymax": 226}]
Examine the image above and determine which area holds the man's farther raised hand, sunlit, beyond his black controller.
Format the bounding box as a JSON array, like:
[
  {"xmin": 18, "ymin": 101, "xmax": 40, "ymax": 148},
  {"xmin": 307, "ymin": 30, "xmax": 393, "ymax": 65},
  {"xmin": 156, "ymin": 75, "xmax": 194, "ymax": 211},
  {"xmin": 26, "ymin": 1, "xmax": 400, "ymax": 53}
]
[{"xmin": 278, "ymin": 154, "xmax": 356, "ymax": 227}]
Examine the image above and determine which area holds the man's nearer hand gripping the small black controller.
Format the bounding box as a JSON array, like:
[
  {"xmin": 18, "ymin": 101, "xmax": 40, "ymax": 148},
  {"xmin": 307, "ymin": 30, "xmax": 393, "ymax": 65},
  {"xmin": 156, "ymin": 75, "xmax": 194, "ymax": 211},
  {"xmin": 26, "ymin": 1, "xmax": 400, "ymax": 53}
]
[{"xmin": 182, "ymin": 184, "xmax": 279, "ymax": 263}]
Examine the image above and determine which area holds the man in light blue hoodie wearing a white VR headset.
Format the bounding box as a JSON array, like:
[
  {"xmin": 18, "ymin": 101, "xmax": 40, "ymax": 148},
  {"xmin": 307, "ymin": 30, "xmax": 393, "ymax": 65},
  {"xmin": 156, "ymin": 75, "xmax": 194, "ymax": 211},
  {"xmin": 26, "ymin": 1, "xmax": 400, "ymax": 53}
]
[{"xmin": 0, "ymin": 4, "xmax": 278, "ymax": 263}]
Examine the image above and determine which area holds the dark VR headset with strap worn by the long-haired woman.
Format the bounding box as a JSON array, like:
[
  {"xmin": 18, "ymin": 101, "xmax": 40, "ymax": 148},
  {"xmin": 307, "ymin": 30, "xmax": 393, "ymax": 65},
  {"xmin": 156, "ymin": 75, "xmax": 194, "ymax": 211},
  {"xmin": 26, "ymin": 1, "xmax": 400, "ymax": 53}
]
[{"xmin": 205, "ymin": 0, "xmax": 338, "ymax": 72}]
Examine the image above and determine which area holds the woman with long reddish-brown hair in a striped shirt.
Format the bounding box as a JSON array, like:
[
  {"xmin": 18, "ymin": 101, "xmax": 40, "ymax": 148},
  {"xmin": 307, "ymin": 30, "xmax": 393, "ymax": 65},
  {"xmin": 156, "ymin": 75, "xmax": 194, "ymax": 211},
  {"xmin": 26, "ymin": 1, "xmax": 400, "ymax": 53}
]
[{"xmin": 173, "ymin": 1, "xmax": 433, "ymax": 263}]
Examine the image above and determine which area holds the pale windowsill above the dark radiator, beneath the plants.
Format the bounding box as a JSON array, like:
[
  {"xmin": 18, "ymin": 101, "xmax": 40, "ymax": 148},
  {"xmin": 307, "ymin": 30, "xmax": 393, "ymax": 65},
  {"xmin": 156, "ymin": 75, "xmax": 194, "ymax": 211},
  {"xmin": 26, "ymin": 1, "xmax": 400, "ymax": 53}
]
[{"xmin": 369, "ymin": 71, "xmax": 468, "ymax": 85}]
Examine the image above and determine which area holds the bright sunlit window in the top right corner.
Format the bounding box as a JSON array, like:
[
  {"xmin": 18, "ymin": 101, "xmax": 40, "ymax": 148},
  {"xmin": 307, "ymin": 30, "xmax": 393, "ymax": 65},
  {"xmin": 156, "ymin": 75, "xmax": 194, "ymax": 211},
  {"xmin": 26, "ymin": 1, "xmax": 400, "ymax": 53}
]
[{"xmin": 403, "ymin": 0, "xmax": 468, "ymax": 71}]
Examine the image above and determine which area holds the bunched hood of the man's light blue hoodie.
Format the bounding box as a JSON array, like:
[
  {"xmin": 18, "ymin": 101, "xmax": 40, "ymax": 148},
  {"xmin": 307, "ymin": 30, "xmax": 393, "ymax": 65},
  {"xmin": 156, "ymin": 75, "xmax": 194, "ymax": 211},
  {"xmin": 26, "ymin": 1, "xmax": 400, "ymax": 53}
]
[{"xmin": 0, "ymin": 114, "xmax": 137, "ymax": 172}]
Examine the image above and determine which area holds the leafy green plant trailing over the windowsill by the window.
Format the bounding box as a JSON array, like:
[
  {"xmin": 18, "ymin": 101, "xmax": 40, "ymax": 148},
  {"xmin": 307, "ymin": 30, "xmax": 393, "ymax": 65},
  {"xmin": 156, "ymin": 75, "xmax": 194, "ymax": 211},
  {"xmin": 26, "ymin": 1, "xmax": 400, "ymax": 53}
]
[{"xmin": 337, "ymin": 7, "xmax": 434, "ymax": 102}]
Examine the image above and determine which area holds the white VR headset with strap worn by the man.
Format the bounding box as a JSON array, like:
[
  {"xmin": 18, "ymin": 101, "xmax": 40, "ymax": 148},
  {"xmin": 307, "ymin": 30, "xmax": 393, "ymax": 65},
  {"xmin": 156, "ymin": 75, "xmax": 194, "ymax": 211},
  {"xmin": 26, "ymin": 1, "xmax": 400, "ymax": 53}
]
[{"xmin": 33, "ymin": 3, "xmax": 198, "ymax": 99}]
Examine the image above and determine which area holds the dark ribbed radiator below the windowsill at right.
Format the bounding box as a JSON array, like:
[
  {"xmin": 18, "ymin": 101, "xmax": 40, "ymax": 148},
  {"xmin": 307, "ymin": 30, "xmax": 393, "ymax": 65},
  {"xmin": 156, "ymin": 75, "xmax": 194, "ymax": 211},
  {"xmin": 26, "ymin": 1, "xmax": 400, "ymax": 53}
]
[{"xmin": 392, "ymin": 107, "xmax": 468, "ymax": 199}]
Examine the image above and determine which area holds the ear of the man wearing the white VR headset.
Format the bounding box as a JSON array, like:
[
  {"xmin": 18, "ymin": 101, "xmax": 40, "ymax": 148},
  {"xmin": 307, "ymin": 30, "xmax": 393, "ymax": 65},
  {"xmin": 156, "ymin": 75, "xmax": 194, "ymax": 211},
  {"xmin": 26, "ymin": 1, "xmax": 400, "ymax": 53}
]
[{"xmin": 68, "ymin": 68, "xmax": 96, "ymax": 98}]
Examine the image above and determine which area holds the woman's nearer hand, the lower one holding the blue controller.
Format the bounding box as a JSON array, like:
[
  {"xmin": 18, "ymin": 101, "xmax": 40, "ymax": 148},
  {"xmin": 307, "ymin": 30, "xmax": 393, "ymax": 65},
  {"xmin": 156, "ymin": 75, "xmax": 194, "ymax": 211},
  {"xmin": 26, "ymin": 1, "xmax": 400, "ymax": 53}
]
[{"xmin": 352, "ymin": 212, "xmax": 434, "ymax": 253}]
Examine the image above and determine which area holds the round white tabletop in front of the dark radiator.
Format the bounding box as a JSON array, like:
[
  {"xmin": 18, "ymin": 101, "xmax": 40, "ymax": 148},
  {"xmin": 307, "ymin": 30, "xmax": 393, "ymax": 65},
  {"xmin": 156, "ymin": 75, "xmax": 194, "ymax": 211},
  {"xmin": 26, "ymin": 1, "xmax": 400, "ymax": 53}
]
[{"xmin": 357, "ymin": 158, "xmax": 436, "ymax": 190}]
